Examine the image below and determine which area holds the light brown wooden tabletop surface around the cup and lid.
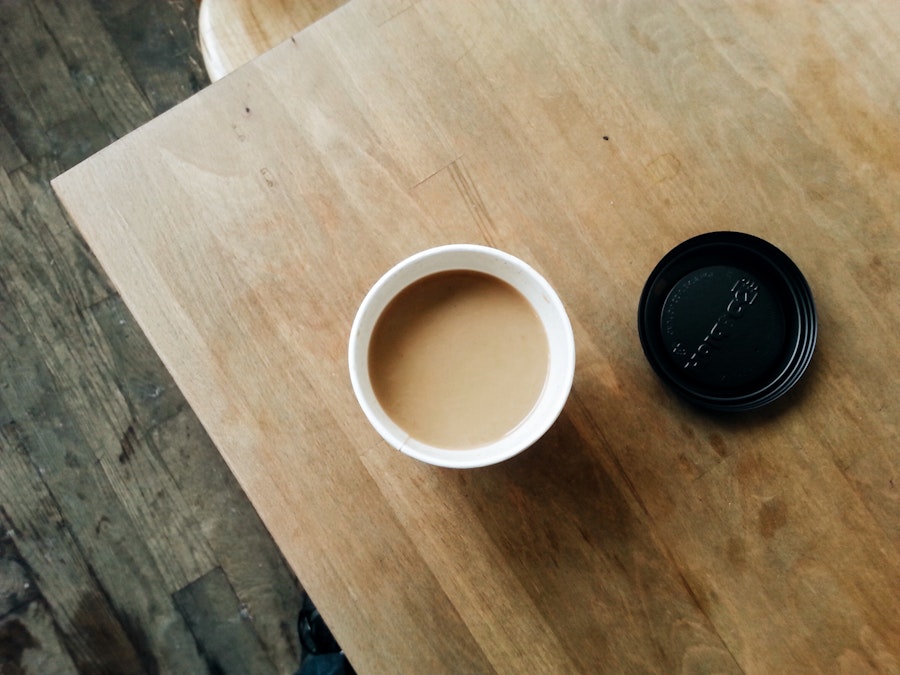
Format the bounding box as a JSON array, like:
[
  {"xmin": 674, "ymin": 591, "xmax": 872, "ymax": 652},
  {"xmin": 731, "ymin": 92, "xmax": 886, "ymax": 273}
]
[{"xmin": 54, "ymin": 0, "xmax": 900, "ymax": 673}]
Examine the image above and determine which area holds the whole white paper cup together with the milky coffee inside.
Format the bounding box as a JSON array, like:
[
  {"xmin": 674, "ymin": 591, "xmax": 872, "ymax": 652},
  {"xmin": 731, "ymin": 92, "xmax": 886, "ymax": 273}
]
[{"xmin": 349, "ymin": 244, "xmax": 575, "ymax": 468}]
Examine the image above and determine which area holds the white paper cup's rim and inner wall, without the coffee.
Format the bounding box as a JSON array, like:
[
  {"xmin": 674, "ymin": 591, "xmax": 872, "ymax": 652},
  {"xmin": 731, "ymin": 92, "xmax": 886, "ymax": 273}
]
[{"xmin": 349, "ymin": 244, "xmax": 575, "ymax": 469}]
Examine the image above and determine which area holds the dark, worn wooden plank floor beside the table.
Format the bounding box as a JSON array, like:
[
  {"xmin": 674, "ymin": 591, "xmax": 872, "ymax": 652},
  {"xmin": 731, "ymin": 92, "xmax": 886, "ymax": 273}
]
[{"xmin": 0, "ymin": 0, "xmax": 301, "ymax": 675}]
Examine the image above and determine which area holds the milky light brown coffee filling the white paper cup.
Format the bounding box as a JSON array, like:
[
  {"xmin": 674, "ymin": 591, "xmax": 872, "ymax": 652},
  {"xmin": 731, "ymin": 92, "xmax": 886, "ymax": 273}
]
[{"xmin": 368, "ymin": 270, "xmax": 549, "ymax": 449}]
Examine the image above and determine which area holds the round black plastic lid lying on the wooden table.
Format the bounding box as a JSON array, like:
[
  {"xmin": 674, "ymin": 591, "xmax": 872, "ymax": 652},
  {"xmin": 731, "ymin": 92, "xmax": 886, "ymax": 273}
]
[{"xmin": 638, "ymin": 232, "xmax": 818, "ymax": 411}]
